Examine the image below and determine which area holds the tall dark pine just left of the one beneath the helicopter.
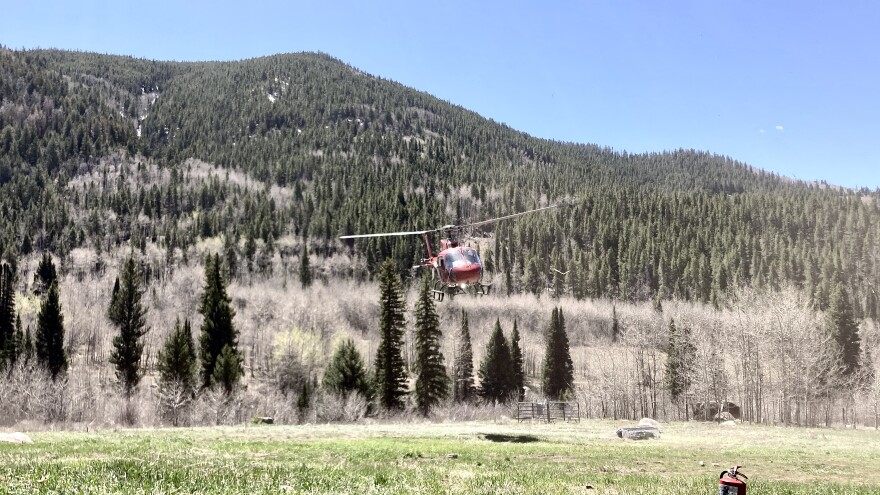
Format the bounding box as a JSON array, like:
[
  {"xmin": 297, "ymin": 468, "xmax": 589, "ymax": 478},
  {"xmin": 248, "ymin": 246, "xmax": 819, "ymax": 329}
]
[{"xmin": 375, "ymin": 258, "xmax": 407, "ymax": 411}]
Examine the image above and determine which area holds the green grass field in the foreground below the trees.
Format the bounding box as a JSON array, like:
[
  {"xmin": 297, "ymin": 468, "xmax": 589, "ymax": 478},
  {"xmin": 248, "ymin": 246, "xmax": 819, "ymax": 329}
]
[{"xmin": 0, "ymin": 421, "xmax": 880, "ymax": 495}]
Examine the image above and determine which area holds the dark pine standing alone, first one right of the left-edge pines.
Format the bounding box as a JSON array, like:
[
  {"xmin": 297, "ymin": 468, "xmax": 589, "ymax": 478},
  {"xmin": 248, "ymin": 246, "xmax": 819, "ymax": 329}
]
[{"xmin": 107, "ymin": 258, "xmax": 147, "ymax": 397}]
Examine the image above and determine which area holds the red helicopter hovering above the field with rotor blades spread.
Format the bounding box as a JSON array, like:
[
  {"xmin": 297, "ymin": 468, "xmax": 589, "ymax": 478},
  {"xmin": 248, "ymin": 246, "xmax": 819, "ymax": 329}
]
[{"xmin": 339, "ymin": 205, "xmax": 559, "ymax": 302}]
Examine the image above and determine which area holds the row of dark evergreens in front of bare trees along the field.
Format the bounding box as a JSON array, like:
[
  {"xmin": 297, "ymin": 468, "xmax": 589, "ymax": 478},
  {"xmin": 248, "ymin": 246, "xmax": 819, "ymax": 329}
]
[{"xmin": 0, "ymin": 254, "xmax": 574, "ymax": 424}]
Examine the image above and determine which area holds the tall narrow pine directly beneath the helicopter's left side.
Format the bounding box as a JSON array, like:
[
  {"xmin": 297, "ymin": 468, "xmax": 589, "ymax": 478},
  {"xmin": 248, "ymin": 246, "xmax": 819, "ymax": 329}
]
[{"xmin": 415, "ymin": 277, "xmax": 449, "ymax": 416}]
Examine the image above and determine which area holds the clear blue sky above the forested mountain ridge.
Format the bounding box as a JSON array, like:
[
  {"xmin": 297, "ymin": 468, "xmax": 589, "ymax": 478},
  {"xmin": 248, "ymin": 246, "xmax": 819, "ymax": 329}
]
[{"xmin": 0, "ymin": 0, "xmax": 880, "ymax": 189}]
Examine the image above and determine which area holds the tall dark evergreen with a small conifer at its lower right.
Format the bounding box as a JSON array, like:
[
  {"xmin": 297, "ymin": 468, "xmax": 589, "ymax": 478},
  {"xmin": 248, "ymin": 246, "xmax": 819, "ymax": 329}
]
[{"xmin": 199, "ymin": 255, "xmax": 241, "ymax": 388}]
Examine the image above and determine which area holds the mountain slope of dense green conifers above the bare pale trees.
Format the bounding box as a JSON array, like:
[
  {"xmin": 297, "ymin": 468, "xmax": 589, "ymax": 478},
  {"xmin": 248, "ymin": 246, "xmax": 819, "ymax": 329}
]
[{"xmin": 0, "ymin": 49, "xmax": 880, "ymax": 318}]
